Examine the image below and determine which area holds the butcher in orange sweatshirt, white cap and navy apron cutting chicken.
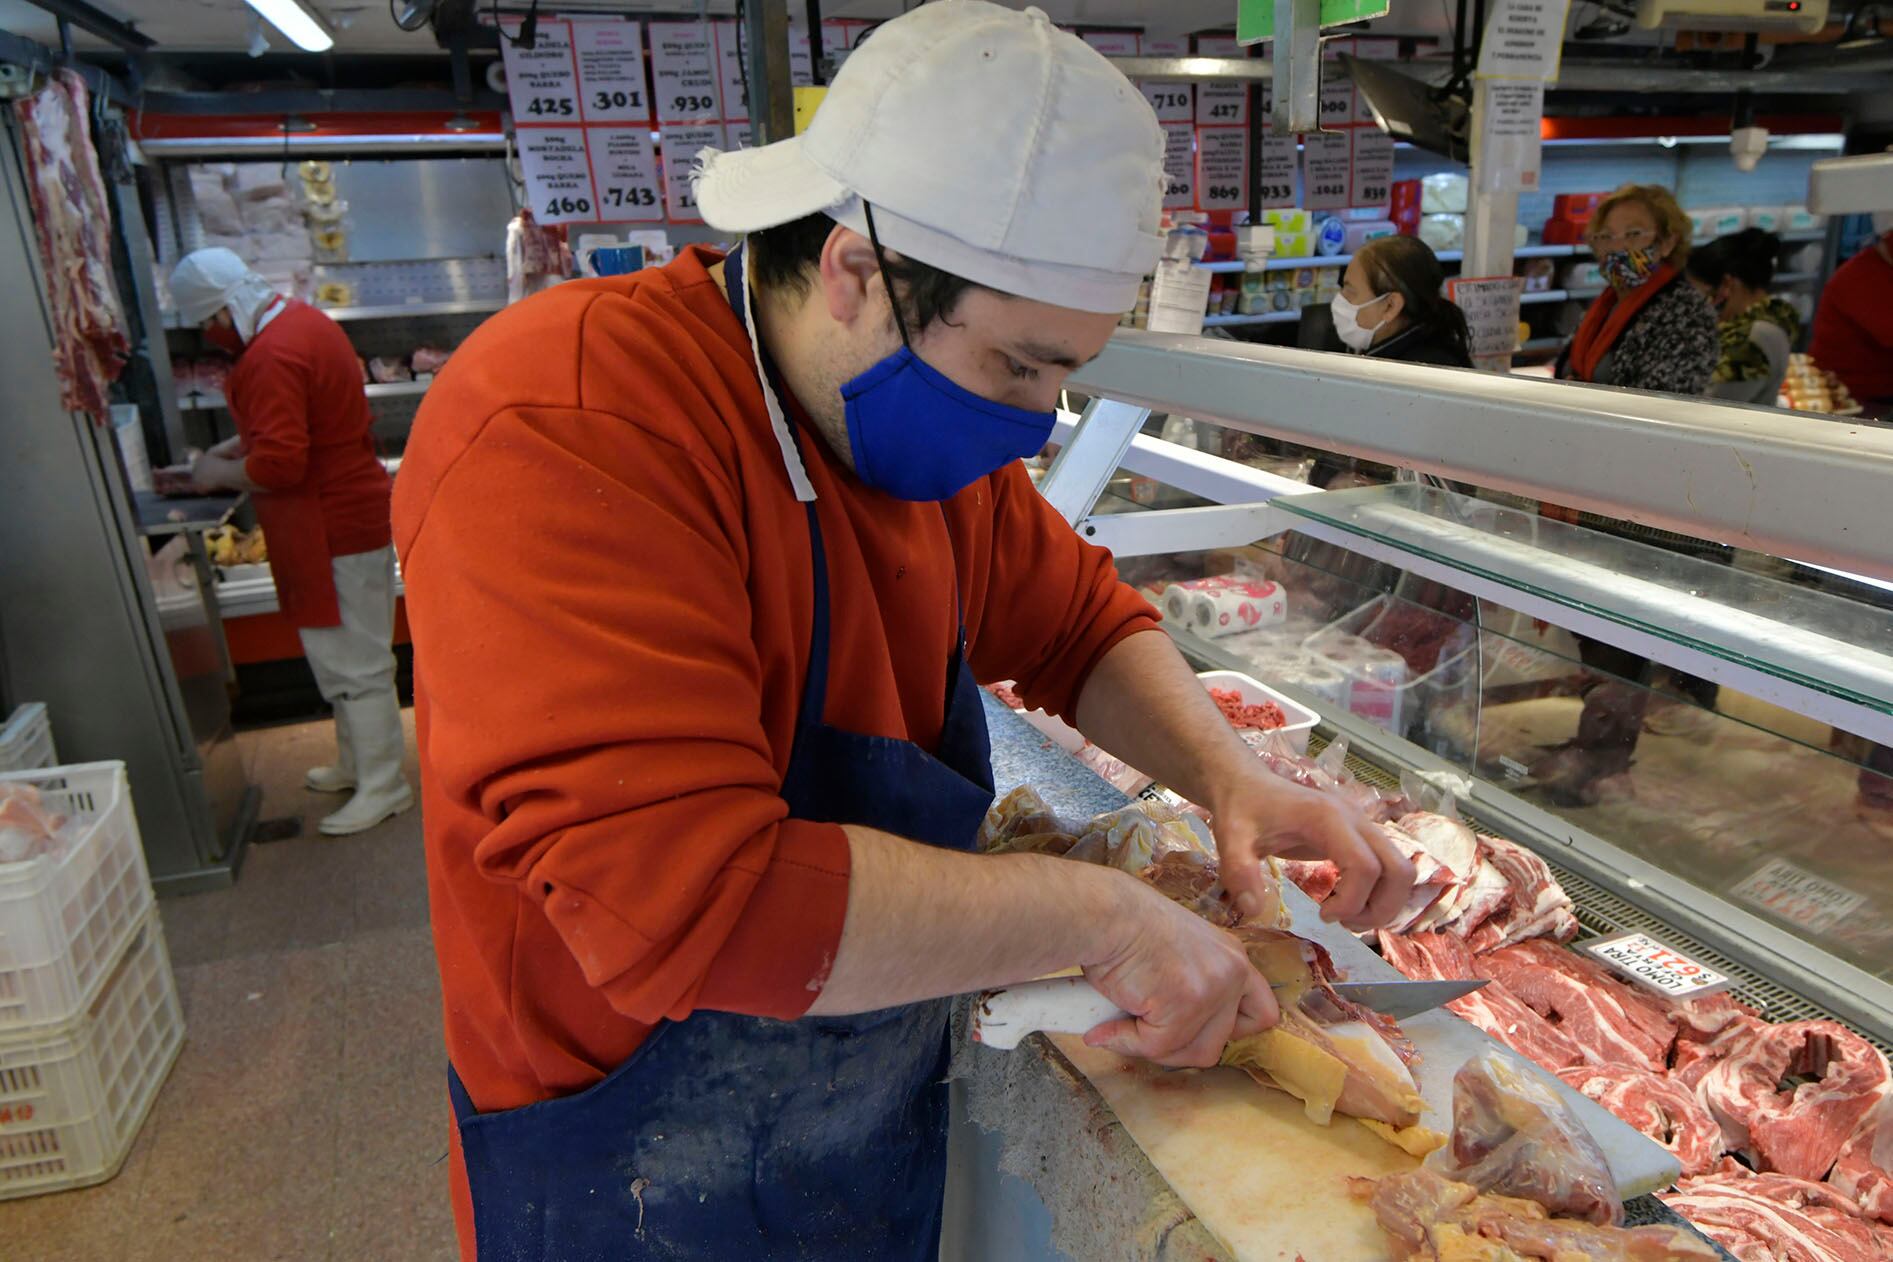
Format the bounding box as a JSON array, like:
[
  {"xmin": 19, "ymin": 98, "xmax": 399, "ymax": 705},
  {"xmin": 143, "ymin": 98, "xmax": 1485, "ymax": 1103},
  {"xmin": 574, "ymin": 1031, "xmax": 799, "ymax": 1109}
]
[{"xmin": 394, "ymin": 0, "xmax": 1412, "ymax": 1262}]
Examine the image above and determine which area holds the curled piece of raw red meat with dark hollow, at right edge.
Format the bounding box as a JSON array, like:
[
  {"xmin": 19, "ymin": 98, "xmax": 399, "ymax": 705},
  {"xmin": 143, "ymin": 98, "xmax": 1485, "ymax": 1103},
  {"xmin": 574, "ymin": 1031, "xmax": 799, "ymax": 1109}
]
[{"xmin": 1696, "ymin": 1022, "xmax": 1893, "ymax": 1179}]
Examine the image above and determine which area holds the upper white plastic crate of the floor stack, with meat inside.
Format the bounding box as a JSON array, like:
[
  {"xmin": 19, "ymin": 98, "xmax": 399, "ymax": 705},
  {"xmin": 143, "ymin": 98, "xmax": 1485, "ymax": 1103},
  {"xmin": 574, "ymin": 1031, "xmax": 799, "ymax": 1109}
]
[{"xmin": 0, "ymin": 762, "xmax": 153, "ymax": 1039}]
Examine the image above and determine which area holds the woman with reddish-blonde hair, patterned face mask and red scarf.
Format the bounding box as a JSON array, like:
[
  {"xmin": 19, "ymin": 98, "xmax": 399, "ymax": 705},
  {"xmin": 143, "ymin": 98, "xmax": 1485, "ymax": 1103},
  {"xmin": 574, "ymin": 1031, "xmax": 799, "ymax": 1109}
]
[{"xmin": 1558, "ymin": 184, "xmax": 1719, "ymax": 394}]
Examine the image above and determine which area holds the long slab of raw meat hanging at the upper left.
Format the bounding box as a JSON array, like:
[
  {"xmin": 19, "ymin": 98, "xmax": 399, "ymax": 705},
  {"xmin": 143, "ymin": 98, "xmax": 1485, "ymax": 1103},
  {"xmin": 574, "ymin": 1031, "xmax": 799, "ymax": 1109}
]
[{"xmin": 15, "ymin": 70, "xmax": 131, "ymax": 422}]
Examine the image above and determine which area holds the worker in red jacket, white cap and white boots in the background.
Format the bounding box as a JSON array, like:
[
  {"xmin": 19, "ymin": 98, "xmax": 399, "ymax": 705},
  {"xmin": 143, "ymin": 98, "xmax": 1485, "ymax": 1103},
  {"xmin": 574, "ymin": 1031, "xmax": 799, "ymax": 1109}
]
[{"xmin": 170, "ymin": 250, "xmax": 415, "ymax": 836}]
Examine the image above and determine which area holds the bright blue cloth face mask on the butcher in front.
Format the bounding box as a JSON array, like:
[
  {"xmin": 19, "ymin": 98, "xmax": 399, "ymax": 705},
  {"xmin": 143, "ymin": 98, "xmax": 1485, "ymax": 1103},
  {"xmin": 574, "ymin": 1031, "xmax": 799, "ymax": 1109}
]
[{"xmin": 840, "ymin": 202, "xmax": 1056, "ymax": 501}]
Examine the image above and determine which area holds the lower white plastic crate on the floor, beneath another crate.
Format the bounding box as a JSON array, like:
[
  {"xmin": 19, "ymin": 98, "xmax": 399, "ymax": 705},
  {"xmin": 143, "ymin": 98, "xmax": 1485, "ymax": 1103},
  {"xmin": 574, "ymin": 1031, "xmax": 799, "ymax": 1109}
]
[{"xmin": 0, "ymin": 910, "xmax": 184, "ymax": 1200}]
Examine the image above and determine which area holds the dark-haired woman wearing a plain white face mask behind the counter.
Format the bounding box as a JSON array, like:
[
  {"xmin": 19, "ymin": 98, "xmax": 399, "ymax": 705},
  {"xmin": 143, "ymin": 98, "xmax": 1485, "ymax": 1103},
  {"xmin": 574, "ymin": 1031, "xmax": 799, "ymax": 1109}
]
[{"xmin": 1331, "ymin": 237, "xmax": 1473, "ymax": 369}]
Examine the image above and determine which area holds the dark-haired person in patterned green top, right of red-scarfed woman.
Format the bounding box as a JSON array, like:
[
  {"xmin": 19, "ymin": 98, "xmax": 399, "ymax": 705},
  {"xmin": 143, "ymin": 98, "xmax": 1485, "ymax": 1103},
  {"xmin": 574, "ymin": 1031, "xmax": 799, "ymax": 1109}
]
[{"xmin": 1687, "ymin": 227, "xmax": 1800, "ymax": 407}]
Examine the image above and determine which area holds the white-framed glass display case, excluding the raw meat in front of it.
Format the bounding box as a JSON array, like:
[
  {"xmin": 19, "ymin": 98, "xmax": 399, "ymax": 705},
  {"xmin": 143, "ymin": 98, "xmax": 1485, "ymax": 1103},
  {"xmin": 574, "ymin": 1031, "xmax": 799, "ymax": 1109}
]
[{"xmin": 1043, "ymin": 339, "xmax": 1893, "ymax": 1043}]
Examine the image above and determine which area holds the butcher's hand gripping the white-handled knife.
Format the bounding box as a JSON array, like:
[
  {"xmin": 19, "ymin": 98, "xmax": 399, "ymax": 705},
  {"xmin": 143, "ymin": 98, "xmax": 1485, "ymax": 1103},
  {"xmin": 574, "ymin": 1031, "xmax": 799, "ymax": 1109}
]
[{"xmin": 1085, "ymin": 880, "xmax": 1278, "ymax": 1069}]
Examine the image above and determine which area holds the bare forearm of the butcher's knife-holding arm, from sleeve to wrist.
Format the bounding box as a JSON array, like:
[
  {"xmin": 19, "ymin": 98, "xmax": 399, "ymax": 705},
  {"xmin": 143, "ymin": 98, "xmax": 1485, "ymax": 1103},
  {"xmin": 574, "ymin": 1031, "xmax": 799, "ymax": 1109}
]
[{"xmin": 808, "ymin": 825, "xmax": 1140, "ymax": 1016}]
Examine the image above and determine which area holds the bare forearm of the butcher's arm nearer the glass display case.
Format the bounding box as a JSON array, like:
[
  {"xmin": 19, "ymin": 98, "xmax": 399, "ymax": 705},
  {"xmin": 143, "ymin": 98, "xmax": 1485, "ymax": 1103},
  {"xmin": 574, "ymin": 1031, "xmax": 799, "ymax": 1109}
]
[{"xmin": 1077, "ymin": 630, "xmax": 1255, "ymax": 821}]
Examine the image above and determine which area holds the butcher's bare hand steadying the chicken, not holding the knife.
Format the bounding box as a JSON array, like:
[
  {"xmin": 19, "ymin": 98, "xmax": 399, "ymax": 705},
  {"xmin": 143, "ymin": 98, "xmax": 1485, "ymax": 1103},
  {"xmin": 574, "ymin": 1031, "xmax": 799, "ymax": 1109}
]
[{"xmin": 1206, "ymin": 762, "xmax": 1414, "ymax": 931}]
